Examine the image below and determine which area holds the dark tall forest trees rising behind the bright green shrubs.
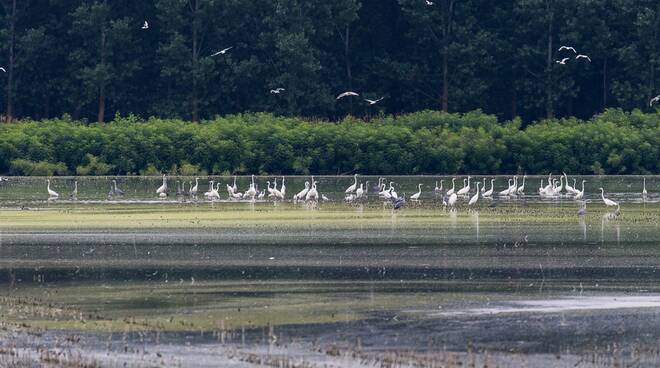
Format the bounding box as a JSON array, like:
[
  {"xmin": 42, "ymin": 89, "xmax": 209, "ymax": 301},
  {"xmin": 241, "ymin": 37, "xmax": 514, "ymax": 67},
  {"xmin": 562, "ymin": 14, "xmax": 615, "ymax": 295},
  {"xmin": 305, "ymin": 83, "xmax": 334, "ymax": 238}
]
[{"xmin": 0, "ymin": 0, "xmax": 660, "ymax": 123}]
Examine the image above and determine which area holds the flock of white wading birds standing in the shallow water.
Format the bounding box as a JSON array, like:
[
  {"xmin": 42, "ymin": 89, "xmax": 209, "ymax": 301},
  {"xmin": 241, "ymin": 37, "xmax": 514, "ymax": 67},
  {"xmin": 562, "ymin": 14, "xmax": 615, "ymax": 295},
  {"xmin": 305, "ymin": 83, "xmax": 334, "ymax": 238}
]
[{"xmin": 38, "ymin": 173, "xmax": 648, "ymax": 211}]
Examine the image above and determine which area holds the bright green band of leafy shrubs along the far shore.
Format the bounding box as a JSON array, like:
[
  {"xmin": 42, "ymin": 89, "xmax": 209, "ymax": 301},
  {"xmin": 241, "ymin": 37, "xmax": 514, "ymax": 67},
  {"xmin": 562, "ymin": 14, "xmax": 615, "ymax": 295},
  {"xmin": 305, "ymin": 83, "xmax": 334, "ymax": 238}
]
[{"xmin": 0, "ymin": 109, "xmax": 660, "ymax": 175}]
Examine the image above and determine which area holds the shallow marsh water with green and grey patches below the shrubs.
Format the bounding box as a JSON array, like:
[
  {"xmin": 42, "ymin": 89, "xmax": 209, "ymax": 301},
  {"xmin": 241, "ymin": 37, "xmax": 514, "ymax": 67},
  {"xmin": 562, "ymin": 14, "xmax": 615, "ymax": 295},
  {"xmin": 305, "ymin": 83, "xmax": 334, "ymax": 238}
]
[{"xmin": 0, "ymin": 177, "xmax": 660, "ymax": 367}]
